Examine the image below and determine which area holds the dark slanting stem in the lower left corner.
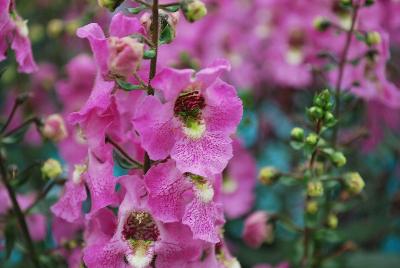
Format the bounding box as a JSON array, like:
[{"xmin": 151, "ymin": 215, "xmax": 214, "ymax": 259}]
[{"xmin": 0, "ymin": 157, "xmax": 40, "ymax": 268}]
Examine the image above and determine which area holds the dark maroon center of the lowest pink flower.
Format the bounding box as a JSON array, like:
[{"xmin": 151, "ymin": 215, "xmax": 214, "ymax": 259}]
[{"xmin": 122, "ymin": 211, "xmax": 160, "ymax": 241}]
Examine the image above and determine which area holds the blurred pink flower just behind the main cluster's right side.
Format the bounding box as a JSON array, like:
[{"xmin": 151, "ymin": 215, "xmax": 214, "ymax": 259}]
[{"xmin": 221, "ymin": 138, "xmax": 257, "ymax": 218}]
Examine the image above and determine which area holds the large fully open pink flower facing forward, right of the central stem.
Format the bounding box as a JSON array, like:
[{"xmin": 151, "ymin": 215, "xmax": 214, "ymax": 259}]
[{"xmin": 133, "ymin": 60, "xmax": 242, "ymax": 177}]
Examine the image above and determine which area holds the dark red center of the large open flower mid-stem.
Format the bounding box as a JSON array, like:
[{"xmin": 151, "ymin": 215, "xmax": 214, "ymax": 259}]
[{"xmin": 174, "ymin": 90, "xmax": 206, "ymax": 123}]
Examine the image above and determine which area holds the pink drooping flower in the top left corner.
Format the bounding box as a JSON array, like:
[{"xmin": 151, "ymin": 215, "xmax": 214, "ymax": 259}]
[{"xmin": 0, "ymin": 0, "xmax": 37, "ymax": 73}]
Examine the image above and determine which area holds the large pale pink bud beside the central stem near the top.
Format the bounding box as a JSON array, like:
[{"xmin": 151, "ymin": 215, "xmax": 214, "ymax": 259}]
[{"xmin": 108, "ymin": 36, "xmax": 144, "ymax": 78}]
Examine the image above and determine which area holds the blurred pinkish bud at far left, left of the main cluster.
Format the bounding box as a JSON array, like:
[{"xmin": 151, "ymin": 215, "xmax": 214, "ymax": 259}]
[{"xmin": 42, "ymin": 114, "xmax": 68, "ymax": 142}]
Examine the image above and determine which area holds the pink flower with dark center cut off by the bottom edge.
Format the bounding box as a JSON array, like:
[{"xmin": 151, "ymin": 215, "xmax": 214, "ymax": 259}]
[{"xmin": 83, "ymin": 175, "xmax": 203, "ymax": 268}]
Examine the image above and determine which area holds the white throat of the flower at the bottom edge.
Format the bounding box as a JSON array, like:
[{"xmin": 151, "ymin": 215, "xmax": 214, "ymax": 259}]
[{"xmin": 126, "ymin": 240, "xmax": 154, "ymax": 268}]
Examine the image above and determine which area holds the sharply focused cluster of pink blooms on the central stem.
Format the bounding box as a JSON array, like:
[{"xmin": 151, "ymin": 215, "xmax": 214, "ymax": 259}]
[{"xmin": 51, "ymin": 9, "xmax": 256, "ymax": 267}]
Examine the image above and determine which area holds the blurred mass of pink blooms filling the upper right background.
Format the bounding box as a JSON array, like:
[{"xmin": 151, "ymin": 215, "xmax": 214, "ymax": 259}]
[{"xmin": 161, "ymin": 0, "xmax": 400, "ymax": 109}]
